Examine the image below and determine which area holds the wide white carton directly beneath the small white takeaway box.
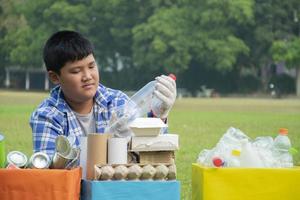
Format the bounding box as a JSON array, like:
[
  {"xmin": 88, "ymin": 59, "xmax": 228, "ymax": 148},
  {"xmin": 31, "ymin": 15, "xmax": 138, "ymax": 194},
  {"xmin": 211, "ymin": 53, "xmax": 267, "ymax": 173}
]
[{"xmin": 131, "ymin": 134, "xmax": 179, "ymax": 151}]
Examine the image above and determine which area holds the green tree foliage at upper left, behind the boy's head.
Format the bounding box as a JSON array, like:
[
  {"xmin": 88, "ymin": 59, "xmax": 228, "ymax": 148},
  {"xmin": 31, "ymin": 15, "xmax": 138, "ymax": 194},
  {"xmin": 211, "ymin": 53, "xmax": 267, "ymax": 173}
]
[{"xmin": 2, "ymin": 0, "xmax": 89, "ymax": 67}]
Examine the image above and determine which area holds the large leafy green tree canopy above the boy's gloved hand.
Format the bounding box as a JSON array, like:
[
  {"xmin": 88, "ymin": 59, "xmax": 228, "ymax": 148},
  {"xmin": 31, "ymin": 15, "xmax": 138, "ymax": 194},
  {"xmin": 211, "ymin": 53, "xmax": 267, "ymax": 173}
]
[{"xmin": 133, "ymin": 0, "xmax": 253, "ymax": 73}]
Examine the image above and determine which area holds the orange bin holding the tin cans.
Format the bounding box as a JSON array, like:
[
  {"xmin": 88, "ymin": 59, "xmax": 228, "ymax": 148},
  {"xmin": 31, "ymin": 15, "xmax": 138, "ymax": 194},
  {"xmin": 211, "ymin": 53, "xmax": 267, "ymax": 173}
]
[{"xmin": 0, "ymin": 168, "xmax": 81, "ymax": 200}]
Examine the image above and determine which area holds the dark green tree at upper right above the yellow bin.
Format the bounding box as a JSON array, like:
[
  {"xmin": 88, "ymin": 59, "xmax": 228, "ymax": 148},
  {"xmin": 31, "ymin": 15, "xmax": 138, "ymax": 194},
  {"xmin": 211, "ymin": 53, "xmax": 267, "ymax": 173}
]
[{"xmin": 237, "ymin": 0, "xmax": 299, "ymax": 94}]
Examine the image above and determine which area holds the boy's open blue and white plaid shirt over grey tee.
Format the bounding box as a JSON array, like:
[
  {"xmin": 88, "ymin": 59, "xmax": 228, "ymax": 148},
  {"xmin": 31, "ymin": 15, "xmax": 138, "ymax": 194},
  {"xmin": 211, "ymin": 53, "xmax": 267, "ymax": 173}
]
[{"xmin": 30, "ymin": 84, "xmax": 129, "ymax": 156}]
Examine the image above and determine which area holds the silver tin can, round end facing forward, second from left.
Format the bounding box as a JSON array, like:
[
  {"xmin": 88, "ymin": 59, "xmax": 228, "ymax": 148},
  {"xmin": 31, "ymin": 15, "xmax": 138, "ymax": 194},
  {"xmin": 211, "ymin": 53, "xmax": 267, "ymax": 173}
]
[{"xmin": 28, "ymin": 152, "xmax": 51, "ymax": 169}]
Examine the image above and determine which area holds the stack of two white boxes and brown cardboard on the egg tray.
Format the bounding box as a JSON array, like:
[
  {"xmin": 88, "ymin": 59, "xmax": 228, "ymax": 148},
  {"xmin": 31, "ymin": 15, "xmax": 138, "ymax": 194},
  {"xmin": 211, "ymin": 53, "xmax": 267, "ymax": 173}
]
[{"xmin": 130, "ymin": 118, "xmax": 179, "ymax": 164}]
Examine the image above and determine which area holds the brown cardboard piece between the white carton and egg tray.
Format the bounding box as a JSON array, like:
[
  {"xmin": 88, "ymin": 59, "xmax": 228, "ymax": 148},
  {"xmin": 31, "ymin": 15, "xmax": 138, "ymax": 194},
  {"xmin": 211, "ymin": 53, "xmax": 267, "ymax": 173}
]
[{"xmin": 139, "ymin": 151, "xmax": 175, "ymax": 164}]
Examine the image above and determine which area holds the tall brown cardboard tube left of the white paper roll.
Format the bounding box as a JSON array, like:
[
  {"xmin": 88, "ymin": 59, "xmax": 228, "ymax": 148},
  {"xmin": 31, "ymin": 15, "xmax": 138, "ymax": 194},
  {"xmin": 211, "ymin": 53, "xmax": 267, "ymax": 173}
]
[{"xmin": 87, "ymin": 133, "xmax": 109, "ymax": 180}]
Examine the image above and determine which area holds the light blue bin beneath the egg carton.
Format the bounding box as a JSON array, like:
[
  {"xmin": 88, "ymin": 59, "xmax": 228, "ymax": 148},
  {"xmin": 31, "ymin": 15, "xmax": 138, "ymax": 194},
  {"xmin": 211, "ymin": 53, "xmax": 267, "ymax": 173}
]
[{"xmin": 81, "ymin": 180, "xmax": 180, "ymax": 200}]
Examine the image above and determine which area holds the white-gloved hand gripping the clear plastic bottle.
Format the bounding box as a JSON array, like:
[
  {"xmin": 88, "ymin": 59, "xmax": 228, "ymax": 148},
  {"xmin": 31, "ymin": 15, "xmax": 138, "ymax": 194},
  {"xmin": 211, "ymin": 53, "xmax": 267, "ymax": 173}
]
[{"xmin": 153, "ymin": 75, "xmax": 177, "ymax": 119}]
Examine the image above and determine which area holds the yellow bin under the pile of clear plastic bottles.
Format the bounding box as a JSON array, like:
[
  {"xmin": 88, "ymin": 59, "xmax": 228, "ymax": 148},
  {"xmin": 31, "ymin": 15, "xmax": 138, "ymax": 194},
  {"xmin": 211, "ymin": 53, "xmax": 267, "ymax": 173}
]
[{"xmin": 192, "ymin": 164, "xmax": 300, "ymax": 200}]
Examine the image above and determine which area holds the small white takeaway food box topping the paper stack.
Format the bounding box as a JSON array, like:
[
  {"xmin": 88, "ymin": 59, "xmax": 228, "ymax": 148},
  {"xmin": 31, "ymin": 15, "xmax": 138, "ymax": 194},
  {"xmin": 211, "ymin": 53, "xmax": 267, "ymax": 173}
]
[{"xmin": 129, "ymin": 117, "xmax": 168, "ymax": 136}]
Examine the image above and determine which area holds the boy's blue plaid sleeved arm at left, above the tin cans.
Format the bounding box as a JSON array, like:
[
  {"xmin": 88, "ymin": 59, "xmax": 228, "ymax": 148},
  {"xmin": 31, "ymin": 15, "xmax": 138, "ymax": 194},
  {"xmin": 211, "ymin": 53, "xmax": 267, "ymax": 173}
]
[{"xmin": 30, "ymin": 112, "xmax": 63, "ymax": 157}]
